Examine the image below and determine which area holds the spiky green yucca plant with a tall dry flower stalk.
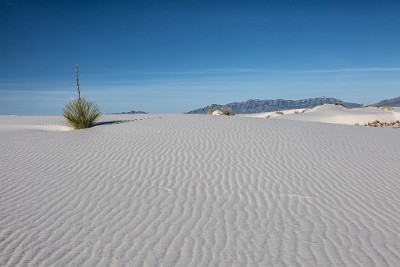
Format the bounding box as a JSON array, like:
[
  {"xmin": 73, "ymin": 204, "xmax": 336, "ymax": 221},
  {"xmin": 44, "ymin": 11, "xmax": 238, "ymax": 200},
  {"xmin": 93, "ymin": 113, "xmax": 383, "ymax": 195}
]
[{"xmin": 63, "ymin": 64, "xmax": 101, "ymax": 130}]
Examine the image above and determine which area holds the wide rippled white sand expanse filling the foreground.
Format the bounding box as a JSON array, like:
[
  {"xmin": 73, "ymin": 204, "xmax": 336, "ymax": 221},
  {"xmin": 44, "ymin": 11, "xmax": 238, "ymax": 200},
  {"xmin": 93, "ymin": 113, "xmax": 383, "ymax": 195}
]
[{"xmin": 0, "ymin": 113, "xmax": 400, "ymax": 266}]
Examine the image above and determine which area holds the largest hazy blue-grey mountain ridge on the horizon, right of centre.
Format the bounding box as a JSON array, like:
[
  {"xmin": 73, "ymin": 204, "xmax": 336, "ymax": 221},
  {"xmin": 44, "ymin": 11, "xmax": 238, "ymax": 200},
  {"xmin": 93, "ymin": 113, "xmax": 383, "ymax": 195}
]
[{"xmin": 187, "ymin": 96, "xmax": 360, "ymax": 114}]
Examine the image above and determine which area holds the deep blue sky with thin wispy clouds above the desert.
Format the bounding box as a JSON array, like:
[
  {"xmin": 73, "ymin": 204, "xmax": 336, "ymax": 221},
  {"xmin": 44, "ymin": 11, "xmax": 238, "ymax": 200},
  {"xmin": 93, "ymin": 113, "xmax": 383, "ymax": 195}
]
[{"xmin": 0, "ymin": 0, "xmax": 400, "ymax": 115}]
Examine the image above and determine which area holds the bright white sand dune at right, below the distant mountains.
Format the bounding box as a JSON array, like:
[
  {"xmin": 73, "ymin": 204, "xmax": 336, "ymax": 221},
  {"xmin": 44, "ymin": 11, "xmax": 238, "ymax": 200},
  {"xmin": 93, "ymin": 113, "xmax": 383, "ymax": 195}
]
[{"xmin": 241, "ymin": 104, "xmax": 400, "ymax": 125}]
